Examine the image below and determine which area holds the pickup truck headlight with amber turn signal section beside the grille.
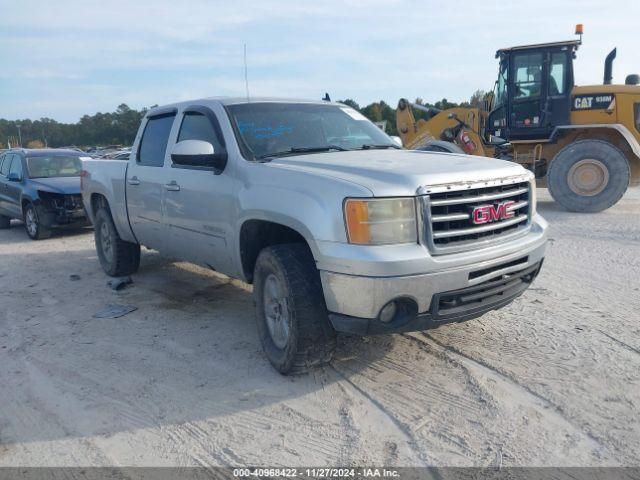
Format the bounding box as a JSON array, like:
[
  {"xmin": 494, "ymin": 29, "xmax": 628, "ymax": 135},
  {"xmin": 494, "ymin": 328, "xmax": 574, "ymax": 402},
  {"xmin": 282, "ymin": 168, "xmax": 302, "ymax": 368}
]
[{"xmin": 344, "ymin": 198, "xmax": 418, "ymax": 245}]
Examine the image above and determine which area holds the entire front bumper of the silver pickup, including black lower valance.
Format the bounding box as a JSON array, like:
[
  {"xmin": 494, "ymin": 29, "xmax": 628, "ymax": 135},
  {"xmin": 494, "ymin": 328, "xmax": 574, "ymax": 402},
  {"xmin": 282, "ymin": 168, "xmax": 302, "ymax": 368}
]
[{"xmin": 320, "ymin": 221, "xmax": 546, "ymax": 334}]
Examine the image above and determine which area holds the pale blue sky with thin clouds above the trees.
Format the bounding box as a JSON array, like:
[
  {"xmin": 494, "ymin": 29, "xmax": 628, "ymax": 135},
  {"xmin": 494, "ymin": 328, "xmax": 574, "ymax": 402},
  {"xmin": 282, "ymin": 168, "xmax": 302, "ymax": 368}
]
[{"xmin": 0, "ymin": 0, "xmax": 640, "ymax": 122}]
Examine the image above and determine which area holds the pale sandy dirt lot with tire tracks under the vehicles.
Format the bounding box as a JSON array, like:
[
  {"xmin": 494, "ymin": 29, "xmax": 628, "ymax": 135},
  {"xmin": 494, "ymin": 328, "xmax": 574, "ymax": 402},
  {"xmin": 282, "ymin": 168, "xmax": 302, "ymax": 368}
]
[{"xmin": 0, "ymin": 189, "xmax": 640, "ymax": 466}]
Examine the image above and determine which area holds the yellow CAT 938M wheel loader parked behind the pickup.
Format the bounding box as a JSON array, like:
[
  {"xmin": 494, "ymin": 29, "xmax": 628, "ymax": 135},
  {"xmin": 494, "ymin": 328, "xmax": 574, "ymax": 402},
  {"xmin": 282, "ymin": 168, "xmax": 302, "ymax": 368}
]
[{"xmin": 396, "ymin": 25, "xmax": 640, "ymax": 212}]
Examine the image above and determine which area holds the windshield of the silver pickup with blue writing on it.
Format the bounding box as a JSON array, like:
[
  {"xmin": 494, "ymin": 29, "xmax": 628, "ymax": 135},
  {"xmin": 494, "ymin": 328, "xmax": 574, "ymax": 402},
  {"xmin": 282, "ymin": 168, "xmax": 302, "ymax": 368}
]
[{"xmin": 227, "ymin": 102, "xmax": 399, "ymax": 160}]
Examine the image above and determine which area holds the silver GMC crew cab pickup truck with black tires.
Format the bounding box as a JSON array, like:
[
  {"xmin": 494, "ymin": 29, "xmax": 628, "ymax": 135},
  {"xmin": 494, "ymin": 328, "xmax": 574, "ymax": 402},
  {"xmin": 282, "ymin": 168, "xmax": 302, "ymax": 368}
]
[{"xmin": 82, "ymin": 98, "xmax": 547, "ymax": 373}]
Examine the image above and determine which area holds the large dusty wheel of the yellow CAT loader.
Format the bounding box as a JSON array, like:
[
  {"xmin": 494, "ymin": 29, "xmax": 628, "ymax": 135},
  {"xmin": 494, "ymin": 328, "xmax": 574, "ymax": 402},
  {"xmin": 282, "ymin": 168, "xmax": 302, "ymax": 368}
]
[{"xmin": 547, "ymin": 140, "xmax": 631, "ymax": 213}]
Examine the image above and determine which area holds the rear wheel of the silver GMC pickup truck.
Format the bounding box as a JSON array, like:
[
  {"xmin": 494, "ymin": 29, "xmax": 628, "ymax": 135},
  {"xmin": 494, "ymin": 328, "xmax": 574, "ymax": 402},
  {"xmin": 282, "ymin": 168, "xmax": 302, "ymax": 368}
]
[{"xmin": 94, "ymin": 207, "xmax": 140, "ymax": 277}]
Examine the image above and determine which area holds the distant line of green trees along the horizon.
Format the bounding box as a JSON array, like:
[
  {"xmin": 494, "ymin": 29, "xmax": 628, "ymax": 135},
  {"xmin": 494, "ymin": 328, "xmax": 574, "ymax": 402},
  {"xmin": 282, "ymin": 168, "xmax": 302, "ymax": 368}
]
[{"xmin": 0, "ymin": 91, "xmax": 484, "ymax": 148}]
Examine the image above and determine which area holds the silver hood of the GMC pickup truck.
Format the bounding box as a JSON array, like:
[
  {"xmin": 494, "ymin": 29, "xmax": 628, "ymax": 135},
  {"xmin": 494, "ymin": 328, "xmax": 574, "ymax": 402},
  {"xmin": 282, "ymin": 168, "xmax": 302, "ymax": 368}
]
[{"xmin": 270, "ymin": 150, "xmax": 526, "ymax": 197}]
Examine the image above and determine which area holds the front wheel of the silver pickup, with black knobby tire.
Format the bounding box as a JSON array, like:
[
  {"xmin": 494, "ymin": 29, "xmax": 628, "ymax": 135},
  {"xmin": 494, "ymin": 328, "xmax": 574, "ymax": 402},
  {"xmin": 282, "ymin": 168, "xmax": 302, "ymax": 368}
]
[{"xmin": 253, "ymin": 244, "xmax": 336, "ymax": 375}]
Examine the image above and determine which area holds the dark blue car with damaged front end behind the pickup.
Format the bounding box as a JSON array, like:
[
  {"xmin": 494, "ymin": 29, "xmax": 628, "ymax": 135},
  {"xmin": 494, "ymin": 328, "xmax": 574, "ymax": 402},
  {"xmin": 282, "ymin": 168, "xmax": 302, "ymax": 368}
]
[{"xmin": 0, "ymin": 149, "xmax": 88, "ymax": 240}]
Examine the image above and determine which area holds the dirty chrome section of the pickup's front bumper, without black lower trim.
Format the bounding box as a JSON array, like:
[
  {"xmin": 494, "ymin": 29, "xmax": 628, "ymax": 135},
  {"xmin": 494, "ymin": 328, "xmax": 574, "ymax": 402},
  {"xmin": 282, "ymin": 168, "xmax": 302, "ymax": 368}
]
[{"xmin": 320, "ymin": 234, "xmax": 546, "ymax": 333}]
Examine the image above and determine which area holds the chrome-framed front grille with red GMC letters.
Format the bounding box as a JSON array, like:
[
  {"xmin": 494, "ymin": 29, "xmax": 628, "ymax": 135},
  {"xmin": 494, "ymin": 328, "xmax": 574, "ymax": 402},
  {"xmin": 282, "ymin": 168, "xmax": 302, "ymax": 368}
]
[{"xmin": 423, "ymin": 181, "xmax": 531, "ymax": 254}]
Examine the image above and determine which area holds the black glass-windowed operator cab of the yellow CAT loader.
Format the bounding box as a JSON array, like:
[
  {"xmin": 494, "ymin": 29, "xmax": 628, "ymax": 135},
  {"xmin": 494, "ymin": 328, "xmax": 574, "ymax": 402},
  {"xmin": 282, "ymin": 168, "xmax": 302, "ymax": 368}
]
[{"xmin": 485, "ymin": 40, "xmax": 580, "ymax": 141}]
